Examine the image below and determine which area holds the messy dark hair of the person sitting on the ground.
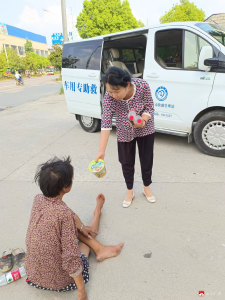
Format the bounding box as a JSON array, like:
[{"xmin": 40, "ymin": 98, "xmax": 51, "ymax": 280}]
[{"xmin": 34, "ymin": 156, "xmax": 73, "ymax": 198}]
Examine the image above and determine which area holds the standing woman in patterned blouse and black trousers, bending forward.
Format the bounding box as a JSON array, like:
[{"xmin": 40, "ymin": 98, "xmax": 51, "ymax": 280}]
[{"xmin": 95, "ymin": 67, "xmax": 155, "ymax": 207}]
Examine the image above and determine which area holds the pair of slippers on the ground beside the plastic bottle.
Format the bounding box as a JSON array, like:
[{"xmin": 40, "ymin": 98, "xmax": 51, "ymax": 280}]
[{"xmin": 0, "ymin": 248, "xmax": 26, "ymax": 273}]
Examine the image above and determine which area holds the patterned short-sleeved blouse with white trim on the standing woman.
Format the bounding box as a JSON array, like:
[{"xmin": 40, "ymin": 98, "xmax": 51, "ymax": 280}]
[{"xmin": 101, "ymin": 78, "xmax": 155, "ymax": 142}]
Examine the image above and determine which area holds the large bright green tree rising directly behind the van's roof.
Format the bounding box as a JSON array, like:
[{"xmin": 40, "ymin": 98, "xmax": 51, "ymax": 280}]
[{"xmin": 76, "ymin": 0, "xmax": 143, "ymax": 39}]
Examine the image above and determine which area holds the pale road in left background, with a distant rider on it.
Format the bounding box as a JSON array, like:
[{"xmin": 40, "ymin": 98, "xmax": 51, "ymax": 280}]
[{"xmin": 0, "ymin": 75, "xmax": 61, "ymax": 111}]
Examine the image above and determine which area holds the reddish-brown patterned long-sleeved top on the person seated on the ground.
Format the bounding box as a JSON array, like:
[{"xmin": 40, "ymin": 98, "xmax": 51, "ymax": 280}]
[{"xmin": 25, "ymin": 195, "xmax": 83, "ymax": 290}]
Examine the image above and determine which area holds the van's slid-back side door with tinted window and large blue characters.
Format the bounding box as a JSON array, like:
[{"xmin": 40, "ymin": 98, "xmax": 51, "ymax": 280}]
[{"xmin": 62, "ymin": 38, "xmax": 103, "ymax": 119}]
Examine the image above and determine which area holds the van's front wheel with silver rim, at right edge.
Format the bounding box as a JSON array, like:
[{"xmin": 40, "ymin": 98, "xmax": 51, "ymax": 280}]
[{"xmin": 194, "ymin": 110, "xmax": 225, "ymax": 157}]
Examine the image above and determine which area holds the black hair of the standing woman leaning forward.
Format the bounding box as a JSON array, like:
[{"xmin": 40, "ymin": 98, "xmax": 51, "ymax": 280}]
[{"xmin": 102, "ymin": 67, "xmax": 132, "ymax": 87}]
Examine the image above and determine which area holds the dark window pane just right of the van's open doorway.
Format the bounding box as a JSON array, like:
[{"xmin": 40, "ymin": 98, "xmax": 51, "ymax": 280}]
[{"xmin": 156, "ymin": 29, "xmax": 183, "ymax": 69}]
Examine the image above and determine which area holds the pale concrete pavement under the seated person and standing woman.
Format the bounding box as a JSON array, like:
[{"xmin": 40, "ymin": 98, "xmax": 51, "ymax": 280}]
[{"xmin": 0, "ymin": 96, "xmax": 225, "ymax": 300}]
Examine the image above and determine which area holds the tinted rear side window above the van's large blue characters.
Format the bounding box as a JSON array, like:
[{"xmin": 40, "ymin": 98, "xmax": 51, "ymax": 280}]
[{"xmin": 62, "ymin": 40, "xmax": 102, "ymax": 70}]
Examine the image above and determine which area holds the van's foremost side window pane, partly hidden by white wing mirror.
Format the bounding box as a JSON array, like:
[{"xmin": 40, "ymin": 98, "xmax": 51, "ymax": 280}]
[{"xmin": 184, "ymin": 31, "xmax": 210, "ymax": 70}]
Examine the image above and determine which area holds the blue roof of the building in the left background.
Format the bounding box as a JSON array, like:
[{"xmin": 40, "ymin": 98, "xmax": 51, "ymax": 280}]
[{"xmin": 6, "ymin": 25, "xmax": 47, "ymax": 44}]
